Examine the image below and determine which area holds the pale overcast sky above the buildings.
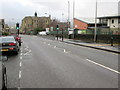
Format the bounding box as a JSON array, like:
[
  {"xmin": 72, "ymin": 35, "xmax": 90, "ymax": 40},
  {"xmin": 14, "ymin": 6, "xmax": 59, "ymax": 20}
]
[{"xmin": 0, "ymin": 0, "xmax": 120, "ymax": 23}]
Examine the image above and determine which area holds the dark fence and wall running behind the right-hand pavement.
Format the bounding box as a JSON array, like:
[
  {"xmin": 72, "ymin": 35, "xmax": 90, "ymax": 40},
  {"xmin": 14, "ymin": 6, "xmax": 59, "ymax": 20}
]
[{"xmin": 48, "ymin": 28, "xmax": 120, "ymax": 43}]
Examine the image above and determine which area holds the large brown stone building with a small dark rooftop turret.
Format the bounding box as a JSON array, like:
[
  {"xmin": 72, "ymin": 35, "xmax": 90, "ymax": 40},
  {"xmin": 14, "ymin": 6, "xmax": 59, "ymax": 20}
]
[{"xmin": 20, "ymin": 12, "xmax": 51, "ymax": 33}]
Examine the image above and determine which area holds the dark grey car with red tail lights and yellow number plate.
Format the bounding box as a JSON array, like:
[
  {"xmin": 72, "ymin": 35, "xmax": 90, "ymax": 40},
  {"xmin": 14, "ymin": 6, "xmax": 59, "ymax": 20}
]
[{"xmin": 0, "ymin": 36, "xmax": 20, "ymax": 54}]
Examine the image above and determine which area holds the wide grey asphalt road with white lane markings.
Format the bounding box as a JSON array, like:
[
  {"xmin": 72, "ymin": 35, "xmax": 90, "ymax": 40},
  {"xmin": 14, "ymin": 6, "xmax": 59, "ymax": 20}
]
[{"xmin": 5, "ymin": 35, "xmax": 120, "ymax": 88}]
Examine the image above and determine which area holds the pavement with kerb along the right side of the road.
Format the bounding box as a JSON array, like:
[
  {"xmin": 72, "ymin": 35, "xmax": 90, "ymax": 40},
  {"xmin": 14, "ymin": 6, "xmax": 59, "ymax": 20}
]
[{"xmin": 41, "ymin": 36, "xmax": 120, "ymax": 54}]
